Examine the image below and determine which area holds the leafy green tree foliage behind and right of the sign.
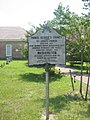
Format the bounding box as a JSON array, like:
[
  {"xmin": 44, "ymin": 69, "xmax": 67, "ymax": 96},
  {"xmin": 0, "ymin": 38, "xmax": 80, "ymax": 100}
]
[{"xmin": 25, "ymin": 3, "xmax": 90, "ymax": 66}]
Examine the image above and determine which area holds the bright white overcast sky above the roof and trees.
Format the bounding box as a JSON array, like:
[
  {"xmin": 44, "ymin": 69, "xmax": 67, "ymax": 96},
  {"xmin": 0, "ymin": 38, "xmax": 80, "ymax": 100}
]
[{"xmin": 0, "ymin": 0, "xmax": 86, "ymax": 29}]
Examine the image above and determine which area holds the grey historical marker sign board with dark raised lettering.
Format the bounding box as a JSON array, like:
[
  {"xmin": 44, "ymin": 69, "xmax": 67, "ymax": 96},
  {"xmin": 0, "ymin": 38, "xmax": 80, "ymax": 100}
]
[{"xmin": 28, "ymin": 29, "xmax": 65, "ymax": 65}]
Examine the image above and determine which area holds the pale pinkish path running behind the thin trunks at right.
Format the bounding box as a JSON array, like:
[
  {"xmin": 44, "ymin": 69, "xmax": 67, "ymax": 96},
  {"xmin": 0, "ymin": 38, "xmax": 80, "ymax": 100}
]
[{"xmin": 56, "ymin": 66, "xmax": 90, "ymax": 85}]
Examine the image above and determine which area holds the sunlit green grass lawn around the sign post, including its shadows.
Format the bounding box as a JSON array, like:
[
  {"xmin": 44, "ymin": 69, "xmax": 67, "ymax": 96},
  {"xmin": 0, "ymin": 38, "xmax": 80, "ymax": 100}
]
[{"xmin": 0, "ymin": 61, "xmax": 90, "ymax": 120}]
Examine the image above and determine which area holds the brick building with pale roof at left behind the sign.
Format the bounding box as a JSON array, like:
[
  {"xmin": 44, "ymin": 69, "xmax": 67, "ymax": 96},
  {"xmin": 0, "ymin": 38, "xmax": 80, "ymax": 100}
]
[{"xmin": 0, "ymin": 27, "xmax": 26, "ymax": 59}]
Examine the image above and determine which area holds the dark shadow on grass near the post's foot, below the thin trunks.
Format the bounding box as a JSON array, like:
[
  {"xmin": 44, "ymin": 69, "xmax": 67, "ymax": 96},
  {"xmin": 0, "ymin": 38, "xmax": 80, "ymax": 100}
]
[{"xmin": 36, "ymin": 94, "xmax": 82, "ymax": 113}]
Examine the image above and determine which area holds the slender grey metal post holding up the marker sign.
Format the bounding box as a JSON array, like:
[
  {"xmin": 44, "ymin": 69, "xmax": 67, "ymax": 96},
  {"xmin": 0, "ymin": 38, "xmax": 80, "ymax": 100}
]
[{"xmin": 45, "ymin": 64, "xmax": 49, "ymax": 120}]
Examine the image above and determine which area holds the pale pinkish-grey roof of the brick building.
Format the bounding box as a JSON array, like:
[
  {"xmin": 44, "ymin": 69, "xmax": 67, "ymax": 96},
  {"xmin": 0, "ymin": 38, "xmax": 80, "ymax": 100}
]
[{"xmin": 0, "ymin": 27, "xmax": 26, "ymax": 41}]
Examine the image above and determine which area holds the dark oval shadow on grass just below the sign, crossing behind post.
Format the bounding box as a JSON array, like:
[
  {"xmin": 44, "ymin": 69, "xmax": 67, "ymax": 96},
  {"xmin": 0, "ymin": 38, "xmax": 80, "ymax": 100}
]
[{"xmin": 20, "ymin": 73, "xmax": 64, "ymax": 82}]
